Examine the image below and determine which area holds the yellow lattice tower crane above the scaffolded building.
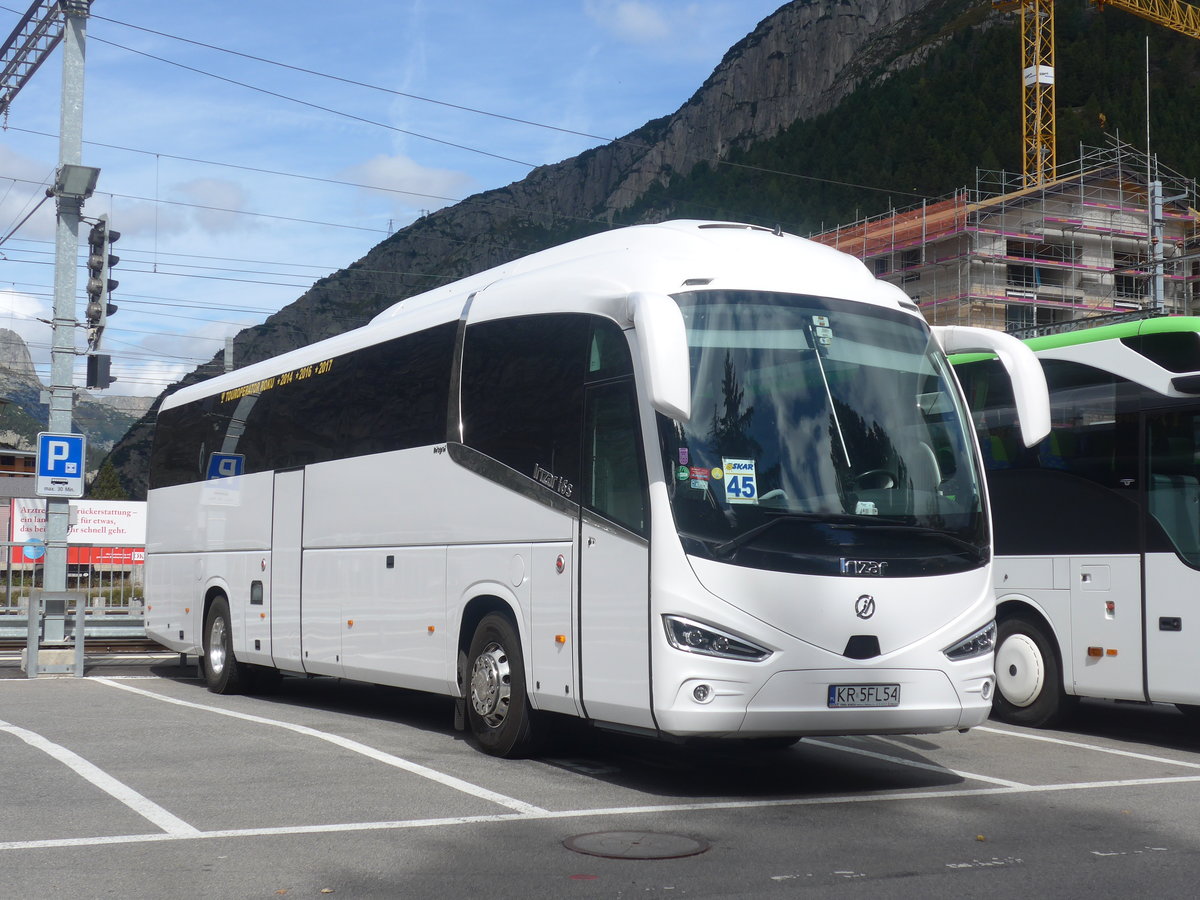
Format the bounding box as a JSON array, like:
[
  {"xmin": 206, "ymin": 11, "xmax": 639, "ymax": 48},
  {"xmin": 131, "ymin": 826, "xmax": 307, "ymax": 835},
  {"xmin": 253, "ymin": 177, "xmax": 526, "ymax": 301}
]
[{"xmin": 992, "ymin": 0, "xmax": 1200, "ymax": 187}]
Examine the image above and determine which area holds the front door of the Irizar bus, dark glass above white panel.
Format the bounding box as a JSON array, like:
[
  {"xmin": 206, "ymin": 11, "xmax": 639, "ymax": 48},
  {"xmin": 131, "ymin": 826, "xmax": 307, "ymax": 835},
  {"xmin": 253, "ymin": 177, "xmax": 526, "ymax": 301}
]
[{"xmin": 578, "ymin": 378, "xmax": 654, "ymax": 728}]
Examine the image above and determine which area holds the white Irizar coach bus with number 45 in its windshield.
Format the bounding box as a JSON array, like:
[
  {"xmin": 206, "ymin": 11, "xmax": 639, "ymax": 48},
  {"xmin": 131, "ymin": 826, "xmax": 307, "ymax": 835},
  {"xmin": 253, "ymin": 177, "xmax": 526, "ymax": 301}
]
[{"xmin": 146, "ymin": 222, "xmax": 1049, "ymax": 756}]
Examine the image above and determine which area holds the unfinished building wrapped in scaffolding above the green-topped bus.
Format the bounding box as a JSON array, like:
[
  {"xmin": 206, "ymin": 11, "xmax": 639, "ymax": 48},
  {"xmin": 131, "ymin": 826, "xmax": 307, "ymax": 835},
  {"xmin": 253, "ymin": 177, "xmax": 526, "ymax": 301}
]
[{"xmin": 815, "ymin": 142, "xmax": 1200, "ymax": 332}]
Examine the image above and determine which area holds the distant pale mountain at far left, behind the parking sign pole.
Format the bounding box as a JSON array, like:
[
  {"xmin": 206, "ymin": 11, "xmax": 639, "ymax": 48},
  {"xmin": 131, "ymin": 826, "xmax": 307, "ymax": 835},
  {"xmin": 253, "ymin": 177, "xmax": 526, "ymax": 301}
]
[{"xmin": 0, "ymin": 328, "xmax": 151, "ymax": 470}]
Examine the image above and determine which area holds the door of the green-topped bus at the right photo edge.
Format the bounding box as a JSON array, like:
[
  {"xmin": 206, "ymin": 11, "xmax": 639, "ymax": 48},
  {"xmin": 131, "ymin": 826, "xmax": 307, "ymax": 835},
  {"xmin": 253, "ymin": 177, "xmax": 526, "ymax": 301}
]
[{"xmin": 1144, "ymin": 409, "xmax": 1200, "ymax": 704}]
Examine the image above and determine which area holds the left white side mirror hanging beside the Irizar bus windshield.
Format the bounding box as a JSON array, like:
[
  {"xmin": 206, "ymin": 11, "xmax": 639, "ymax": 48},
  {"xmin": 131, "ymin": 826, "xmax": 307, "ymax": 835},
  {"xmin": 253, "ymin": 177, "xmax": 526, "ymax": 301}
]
[{"xmin": 629, "ymin": 292, "xmax": 691, "ymax": 422}]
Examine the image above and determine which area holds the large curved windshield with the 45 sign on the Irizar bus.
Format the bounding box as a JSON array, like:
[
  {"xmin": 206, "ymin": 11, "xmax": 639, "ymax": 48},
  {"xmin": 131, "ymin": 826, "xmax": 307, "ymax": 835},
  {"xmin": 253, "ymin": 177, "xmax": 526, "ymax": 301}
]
[{"xmin": 659, "ymin": 290, "xmax": 989, "ymax": 577}]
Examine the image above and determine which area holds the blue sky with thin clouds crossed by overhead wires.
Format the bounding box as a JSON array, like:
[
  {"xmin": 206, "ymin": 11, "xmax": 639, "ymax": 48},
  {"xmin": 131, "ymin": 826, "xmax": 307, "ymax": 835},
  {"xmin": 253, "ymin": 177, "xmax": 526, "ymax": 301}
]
[{"xmin": 0, "ymin": 0, "xmax": 784, "ymax": 396}]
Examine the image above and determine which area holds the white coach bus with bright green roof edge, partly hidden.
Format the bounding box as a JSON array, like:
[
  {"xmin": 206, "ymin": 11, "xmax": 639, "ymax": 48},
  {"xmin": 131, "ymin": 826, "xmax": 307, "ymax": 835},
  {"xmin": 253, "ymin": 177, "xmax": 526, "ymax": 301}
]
[{"xmin": 955, "ymin": 317, "xmax": 1200, "ymax": 726}]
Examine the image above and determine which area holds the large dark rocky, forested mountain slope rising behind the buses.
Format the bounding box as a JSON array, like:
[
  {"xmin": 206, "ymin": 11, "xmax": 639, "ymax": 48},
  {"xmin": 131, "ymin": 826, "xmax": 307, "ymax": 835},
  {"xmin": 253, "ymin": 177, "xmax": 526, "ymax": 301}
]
[{"xmin": 110, "ymin": 0, "xmax": 1200, "ymax": 498}]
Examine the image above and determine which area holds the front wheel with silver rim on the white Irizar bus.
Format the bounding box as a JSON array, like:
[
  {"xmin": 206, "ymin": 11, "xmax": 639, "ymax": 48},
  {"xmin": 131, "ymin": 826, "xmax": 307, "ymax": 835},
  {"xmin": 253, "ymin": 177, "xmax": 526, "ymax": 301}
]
[{"xmin": 466, "ymin": 612, "xmax": 533, "ymax": 760}]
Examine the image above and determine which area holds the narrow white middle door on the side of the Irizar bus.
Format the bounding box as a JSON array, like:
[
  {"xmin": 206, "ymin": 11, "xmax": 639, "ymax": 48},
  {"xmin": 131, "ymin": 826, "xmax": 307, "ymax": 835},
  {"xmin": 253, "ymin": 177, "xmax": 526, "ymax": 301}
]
[{"xmin": 270, "ymin": 469, "xmax": 304, "ymax": 672}]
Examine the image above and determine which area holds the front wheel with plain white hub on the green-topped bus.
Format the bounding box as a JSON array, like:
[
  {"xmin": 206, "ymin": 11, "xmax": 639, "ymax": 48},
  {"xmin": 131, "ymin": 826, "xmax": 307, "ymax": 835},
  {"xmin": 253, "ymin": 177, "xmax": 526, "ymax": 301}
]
[{"xmin": 991, "ymin": 616, "xmax": 1075, "ymax": 728}]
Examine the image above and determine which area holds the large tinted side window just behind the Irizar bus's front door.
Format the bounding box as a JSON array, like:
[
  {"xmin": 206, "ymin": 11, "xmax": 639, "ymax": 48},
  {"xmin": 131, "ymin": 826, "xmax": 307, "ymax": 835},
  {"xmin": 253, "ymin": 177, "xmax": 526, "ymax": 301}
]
[{"xmin": 462, "ymin": 314, "xmax": 590, "ymax": 496}]
